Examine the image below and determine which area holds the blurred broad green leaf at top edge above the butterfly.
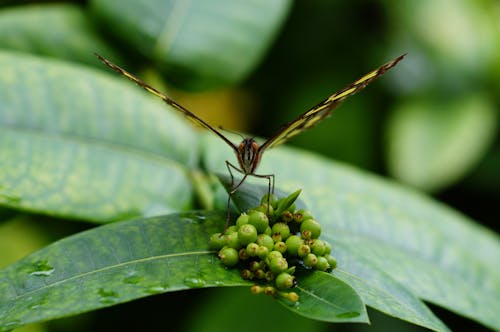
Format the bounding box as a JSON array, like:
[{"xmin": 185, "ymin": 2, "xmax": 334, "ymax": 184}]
[{"xmin": 91, "ymin": 0, "xmax": 291, "ymax": 90}]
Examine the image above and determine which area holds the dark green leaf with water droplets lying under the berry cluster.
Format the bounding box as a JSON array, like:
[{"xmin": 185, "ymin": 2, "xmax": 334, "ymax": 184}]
[{"xmin": 0, "ymin": 212, "xmax": 366, "ymax": 330}]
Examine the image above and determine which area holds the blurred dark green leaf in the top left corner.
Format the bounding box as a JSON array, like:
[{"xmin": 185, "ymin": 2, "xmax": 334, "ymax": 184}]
[{"xmin": 0, "ymin": 3, "xmax": 120, "ymax": 67}]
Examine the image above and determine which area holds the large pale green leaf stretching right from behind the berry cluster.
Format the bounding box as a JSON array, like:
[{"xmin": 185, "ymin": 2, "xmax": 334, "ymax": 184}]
[{"xmin": 205, "ymin": 136, "xmax": 500, "ymax": 331}]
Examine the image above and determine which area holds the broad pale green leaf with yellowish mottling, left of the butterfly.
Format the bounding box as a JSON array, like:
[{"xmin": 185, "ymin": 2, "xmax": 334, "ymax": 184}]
[{"xmin": 0, "ymin": 52, "xmax": 197, "ymax": 221}]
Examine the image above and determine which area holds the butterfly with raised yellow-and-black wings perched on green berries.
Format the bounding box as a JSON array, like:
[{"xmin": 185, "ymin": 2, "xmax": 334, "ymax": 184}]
[{"xmin": 96, "ymin": 54, "xmax": 406, "ymax": 231}]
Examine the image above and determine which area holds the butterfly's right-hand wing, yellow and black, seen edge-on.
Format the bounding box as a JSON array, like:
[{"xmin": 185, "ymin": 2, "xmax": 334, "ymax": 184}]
[{"xmin": 259, "ymin": 54, "xmax": 406, "ymax": 153}]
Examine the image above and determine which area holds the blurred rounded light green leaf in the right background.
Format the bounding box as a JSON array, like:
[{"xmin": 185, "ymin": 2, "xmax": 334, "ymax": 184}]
[{"xmin": 387, "ymin": 94, "xmax": 498, "ymax": 191}]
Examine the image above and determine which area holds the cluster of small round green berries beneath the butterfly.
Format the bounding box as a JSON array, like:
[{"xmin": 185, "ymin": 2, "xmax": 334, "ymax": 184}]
[{"xmin": 210, "ymin": 190, "xmax": 337, "ymax": 302}]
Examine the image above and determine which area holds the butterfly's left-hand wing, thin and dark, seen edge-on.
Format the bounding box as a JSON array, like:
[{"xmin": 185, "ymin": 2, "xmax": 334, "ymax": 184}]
[{"xmin": 95, "ymin": 53, "xmax": 238, "ymax": 151}]
